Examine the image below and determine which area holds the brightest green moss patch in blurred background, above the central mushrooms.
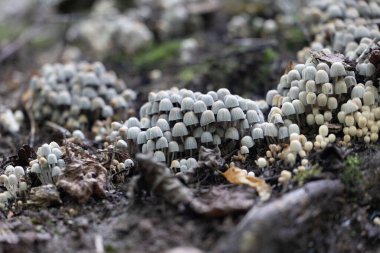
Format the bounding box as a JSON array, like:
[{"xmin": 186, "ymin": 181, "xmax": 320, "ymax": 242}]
[{"xmin": 133, "ymin": 40, "xmax": 181, "ymax": 67}]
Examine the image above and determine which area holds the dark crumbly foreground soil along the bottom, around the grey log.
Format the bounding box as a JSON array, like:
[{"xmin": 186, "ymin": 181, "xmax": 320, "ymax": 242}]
[{"xmin": 0, "ymin": 142, "xmax": 380, "ymax": 252}]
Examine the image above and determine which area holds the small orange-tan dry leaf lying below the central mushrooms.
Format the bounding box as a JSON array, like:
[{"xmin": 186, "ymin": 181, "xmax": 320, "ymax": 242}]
[{"xmin": 223, "ymin": 163, "xmax": 272, "ymax": 201}]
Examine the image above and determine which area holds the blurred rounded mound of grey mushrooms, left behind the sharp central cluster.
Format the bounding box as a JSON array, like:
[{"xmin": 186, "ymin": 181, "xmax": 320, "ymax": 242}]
[{"xmin": 30, "ymin": 62, "xmax": 136, "ymax": 130}]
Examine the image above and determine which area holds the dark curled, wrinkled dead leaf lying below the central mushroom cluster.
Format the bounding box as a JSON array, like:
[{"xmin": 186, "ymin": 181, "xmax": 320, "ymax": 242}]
[{"xmin": 129, "ymin": 154, "xmax": 256, "ymax": 217}]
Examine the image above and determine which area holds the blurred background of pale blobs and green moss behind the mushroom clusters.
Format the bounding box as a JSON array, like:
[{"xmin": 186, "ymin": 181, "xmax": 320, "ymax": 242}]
[{"xmin": 0, "ymin": 0, "xmax": 308, "ymax": 107}]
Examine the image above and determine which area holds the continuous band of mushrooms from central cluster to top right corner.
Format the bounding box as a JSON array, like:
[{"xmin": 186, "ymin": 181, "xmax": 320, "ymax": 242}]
[{"xmin": 103, "ymin": 1, "xmax": 380, "ymax": 171}]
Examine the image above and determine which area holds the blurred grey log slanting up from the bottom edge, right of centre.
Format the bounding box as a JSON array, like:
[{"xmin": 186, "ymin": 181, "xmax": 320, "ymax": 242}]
[{"xmin": 213, "ymin": 180, "xmax": 344, "ymax": 253}]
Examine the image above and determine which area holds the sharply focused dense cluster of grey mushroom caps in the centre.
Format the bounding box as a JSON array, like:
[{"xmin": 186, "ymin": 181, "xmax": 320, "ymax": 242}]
[{"xmin": 101, "ymin": 88, "xmax": 268, "ymax": 168}]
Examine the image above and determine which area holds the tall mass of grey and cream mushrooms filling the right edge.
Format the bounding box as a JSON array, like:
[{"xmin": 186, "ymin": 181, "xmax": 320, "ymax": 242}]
[{"xmin": 254, "ymin": 1, "xmax": 380, "ymax": 176}]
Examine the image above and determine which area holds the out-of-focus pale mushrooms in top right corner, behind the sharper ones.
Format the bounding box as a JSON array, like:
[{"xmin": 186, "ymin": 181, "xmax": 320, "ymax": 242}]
[{"xmin": 298, "ymin": 0, "xmax": 380, "ymax": 62}]
